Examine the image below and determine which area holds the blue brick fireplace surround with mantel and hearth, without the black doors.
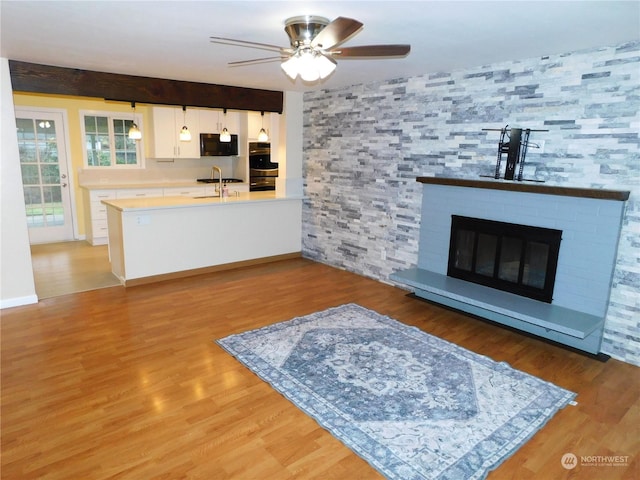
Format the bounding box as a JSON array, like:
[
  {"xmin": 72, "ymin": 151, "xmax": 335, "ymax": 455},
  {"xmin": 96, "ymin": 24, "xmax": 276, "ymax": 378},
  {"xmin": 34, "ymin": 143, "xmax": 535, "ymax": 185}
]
[{"xmin": 391, "ymin": 177, "xmax": 629, "ymax": 354}]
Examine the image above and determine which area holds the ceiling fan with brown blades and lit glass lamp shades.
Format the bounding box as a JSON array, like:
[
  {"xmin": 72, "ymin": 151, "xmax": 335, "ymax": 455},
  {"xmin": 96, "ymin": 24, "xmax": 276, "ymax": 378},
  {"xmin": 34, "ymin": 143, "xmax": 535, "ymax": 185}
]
[{"xmin": 210, "ymin": 15, "xmax": 411, "ymax": 82}]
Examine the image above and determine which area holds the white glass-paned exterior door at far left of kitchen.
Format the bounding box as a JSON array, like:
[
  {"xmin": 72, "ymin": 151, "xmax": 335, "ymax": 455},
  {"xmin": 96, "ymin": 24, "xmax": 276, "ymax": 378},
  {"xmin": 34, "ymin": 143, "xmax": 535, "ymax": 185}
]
[{"xmin": 16, "ymin": 107, "xmax": 74, "ymax": 244}]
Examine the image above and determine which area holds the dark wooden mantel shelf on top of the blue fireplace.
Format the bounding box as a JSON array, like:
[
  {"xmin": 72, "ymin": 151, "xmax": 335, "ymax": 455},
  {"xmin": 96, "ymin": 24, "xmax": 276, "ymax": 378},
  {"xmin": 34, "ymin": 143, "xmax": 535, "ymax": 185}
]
[{"xmin": 416, "ymin": 177, "xmax": 630, "ymax": 202}]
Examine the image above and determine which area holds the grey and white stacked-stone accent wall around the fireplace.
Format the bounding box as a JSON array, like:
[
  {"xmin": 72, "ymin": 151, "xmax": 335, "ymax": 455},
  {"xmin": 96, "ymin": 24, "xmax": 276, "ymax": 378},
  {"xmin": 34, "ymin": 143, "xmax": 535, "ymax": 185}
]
[{"xmin": 302, "ymin": 42, "xmax": 640, "ymax": 365}]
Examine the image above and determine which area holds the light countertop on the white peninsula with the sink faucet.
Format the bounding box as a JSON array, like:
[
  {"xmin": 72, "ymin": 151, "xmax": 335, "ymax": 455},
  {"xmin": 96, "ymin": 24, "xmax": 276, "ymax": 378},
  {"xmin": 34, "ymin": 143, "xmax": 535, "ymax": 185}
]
[{"xmin": 102, "ymin": 191, "xmax": 303, "ymax": 212}]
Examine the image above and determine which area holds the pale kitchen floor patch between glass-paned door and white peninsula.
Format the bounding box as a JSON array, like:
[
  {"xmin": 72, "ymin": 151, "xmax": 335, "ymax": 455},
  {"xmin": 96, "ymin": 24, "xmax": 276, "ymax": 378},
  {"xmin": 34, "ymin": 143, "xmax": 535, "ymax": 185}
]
[{"xmin": 31, "ymin": 241, "xmax": 120, "ymax": 299}]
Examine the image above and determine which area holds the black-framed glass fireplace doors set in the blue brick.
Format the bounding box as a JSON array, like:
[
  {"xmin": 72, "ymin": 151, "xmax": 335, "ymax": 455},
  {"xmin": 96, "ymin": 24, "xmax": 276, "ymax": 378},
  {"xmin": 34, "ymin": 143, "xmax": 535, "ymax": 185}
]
[{"xmin": 447, "ymin": 215, "xmax": 562, "ymax": 303}]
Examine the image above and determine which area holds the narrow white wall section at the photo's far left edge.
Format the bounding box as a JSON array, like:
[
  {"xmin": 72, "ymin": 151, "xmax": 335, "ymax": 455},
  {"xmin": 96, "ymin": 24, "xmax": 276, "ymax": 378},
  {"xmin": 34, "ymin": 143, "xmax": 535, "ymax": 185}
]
[{"xmin": 0, "ymin": 58, "xmax": 38, "ymax": 308}]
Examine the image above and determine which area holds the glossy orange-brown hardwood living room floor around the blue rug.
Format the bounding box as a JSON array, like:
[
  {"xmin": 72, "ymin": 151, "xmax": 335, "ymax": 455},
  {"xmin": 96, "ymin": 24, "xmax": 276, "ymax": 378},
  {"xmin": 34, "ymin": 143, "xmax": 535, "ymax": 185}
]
[{"xmin": 1, "ymin": 259, "xmax": 640, "ymax": 480}]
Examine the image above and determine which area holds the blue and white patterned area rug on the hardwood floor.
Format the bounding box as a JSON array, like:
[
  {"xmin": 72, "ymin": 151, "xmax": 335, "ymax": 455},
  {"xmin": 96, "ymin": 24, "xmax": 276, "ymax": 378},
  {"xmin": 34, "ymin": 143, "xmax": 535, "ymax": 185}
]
[{"xmin": 217, "ymin": 304, "xmax": 575, "ymax": 480}]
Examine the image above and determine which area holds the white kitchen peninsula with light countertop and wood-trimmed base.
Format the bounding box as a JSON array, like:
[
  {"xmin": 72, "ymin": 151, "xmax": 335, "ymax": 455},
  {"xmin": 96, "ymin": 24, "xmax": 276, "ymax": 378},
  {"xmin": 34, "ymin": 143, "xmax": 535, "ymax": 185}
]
[{"xmin": 102, "ymin": 192, "xmax": 302, "ymax": 286}]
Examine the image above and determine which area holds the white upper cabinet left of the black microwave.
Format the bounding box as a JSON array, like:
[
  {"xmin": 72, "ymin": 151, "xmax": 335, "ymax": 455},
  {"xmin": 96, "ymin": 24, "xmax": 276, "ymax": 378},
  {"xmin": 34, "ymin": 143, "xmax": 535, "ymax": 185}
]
[{"xmin": 150, "ymin": 107, "xmax": 200, "ymax": 158}]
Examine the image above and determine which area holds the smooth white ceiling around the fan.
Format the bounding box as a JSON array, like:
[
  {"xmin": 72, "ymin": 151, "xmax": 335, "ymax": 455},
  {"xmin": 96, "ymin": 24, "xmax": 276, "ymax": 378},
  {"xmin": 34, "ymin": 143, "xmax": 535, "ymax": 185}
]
[{"xmin": 0, "ymin": 0, "xmax": 640, "ymax": 90}]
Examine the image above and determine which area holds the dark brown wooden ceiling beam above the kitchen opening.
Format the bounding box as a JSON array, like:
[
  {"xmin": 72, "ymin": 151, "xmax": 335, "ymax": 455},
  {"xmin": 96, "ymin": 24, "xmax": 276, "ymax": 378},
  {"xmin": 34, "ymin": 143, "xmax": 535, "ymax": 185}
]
[{"xmin": 9, "ymin": 60, "xmax": 284, "ymax": 113}]
